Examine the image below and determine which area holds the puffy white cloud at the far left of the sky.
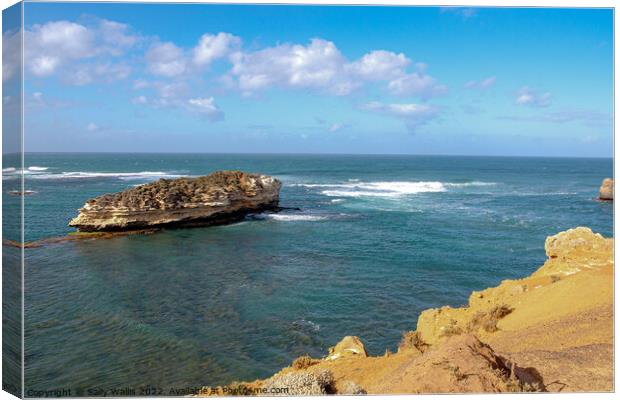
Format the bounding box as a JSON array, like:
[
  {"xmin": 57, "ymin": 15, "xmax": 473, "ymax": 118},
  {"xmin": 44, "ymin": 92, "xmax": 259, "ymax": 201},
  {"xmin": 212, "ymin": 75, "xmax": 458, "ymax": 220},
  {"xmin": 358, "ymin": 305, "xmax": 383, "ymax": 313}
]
[{"xmin": 24, "ymin": 20, "xmax": 138, "ymax": 84}]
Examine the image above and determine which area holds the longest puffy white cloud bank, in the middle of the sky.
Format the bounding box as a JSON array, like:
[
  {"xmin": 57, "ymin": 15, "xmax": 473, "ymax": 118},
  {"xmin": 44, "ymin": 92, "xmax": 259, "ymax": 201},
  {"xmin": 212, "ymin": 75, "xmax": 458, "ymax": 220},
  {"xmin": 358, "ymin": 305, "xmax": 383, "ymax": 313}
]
[{"xmin": 230, "ymin": 39, "xmax": 447, "ymax": 98}]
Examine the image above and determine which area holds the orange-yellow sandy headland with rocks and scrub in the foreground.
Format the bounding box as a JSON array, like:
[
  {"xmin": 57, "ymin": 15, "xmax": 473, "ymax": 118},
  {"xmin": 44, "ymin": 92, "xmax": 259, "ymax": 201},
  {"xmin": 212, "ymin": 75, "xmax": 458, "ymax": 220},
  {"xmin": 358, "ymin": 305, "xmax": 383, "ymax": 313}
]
[{"xmin": 199, "ymin": 227, "xmax": 614, "ymax": 395}]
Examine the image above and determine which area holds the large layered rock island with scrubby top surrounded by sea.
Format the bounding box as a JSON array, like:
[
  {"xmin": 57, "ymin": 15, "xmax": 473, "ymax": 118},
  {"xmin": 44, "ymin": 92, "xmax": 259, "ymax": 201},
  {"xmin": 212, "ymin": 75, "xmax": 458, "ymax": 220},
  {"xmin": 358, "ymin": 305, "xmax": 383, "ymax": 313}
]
[{"xmin": 69, "ymin": 171, "xmax": 281, "ymax": 232}]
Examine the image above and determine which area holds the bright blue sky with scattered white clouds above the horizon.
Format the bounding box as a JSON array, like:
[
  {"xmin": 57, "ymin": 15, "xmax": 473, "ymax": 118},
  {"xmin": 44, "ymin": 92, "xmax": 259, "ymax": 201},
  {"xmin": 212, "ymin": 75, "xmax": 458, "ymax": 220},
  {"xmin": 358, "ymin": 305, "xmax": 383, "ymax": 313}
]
[{"xmin": 3, "ymin": 2, "xmax": 613, "ymax": 157}]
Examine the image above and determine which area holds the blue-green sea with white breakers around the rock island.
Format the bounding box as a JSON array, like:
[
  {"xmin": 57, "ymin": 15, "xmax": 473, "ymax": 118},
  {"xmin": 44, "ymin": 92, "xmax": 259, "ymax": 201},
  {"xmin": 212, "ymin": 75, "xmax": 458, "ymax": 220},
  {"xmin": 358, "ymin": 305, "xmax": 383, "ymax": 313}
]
[{"xmin": 8, "ymin": 154, "xmax": 613, "ymax": 394}]
